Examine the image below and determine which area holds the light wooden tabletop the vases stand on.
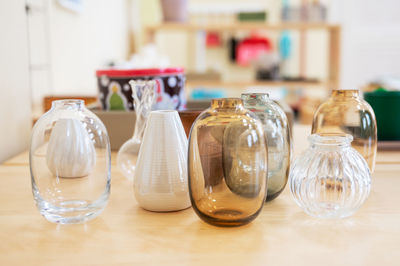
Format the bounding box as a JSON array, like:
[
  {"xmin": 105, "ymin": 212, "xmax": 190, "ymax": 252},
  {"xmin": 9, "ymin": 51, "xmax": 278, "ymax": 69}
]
[{"xmin": 0, "ymin": 125, "xmax": 400, "ymax": 266}]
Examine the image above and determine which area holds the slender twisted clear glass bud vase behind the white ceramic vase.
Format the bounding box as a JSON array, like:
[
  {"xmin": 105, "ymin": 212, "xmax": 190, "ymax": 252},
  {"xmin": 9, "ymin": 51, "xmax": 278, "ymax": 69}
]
[{"xmin": 117, "ymin": 80, "xmax": 156, "ymax": 180}]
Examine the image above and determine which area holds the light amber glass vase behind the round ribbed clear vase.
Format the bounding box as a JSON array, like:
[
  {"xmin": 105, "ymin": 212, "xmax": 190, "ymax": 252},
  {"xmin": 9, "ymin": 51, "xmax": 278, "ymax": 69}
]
[{"xmin": 312, "ymin": 90, "xmax": 377, "ymax": 173}]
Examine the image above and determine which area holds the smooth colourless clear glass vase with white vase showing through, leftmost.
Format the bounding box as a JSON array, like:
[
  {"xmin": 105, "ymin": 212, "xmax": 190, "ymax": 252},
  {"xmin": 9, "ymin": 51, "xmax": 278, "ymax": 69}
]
[{"xmin": 29, "ymin": 100, "xmax": 111, "ymax": 224}]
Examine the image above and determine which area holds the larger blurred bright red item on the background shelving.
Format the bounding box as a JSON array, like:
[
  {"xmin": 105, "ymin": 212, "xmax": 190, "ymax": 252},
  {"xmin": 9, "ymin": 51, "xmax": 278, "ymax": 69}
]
[{"xmin": 236, "ymin": 36, "xmax": 272, "ymax": 66}]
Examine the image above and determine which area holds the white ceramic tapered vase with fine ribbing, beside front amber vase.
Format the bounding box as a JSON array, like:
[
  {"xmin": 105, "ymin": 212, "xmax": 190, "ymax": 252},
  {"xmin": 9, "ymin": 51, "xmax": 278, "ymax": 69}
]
[{"xmin": 134, "ymin": 111, "xmax": 191, "ymax": 212}]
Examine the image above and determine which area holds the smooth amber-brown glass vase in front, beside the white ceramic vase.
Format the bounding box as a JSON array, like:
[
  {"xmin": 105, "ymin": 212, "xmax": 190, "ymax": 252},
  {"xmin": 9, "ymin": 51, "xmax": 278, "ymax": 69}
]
[{"xmin": 188, "ymin": 98, "xmax": 268, "ymax": 226}]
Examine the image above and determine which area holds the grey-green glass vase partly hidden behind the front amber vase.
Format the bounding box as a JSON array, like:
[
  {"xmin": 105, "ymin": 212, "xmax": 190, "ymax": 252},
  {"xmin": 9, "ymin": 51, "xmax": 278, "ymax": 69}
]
[{"xmin": 242, "ymin": 93, "xmax": 291, "ymax": 201}]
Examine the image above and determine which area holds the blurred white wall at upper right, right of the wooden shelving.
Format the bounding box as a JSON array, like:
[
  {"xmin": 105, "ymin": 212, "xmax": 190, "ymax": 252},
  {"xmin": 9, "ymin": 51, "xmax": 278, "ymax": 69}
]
[{"xmin": 330, "ymin": 0, "xmax": 400, "ymax": 88}]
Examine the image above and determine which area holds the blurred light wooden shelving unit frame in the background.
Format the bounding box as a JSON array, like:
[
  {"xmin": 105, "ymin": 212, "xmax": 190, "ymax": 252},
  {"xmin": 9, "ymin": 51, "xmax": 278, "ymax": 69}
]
[{"xmin": 145, "ymin": 22, "xmax": 341, "ymax": 93}]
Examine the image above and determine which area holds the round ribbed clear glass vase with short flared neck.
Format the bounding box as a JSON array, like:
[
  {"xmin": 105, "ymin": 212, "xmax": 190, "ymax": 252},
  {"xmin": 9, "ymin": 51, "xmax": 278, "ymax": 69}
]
[{"xmin": 289, "ymin": 134, "xmax": 371, "ymax": 218}]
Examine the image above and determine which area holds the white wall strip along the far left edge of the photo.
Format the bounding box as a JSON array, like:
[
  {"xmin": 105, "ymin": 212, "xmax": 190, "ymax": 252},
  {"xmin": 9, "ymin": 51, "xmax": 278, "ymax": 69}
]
[{"xmin": 0, "ymin": 0, "xmax": 32, "ymax": 162}]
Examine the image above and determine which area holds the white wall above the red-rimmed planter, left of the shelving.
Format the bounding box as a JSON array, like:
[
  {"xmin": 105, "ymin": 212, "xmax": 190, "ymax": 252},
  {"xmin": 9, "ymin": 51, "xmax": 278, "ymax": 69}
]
[{"xmin": 30, "ymin": 0, "xmax": 130, "ymax": 109}]
